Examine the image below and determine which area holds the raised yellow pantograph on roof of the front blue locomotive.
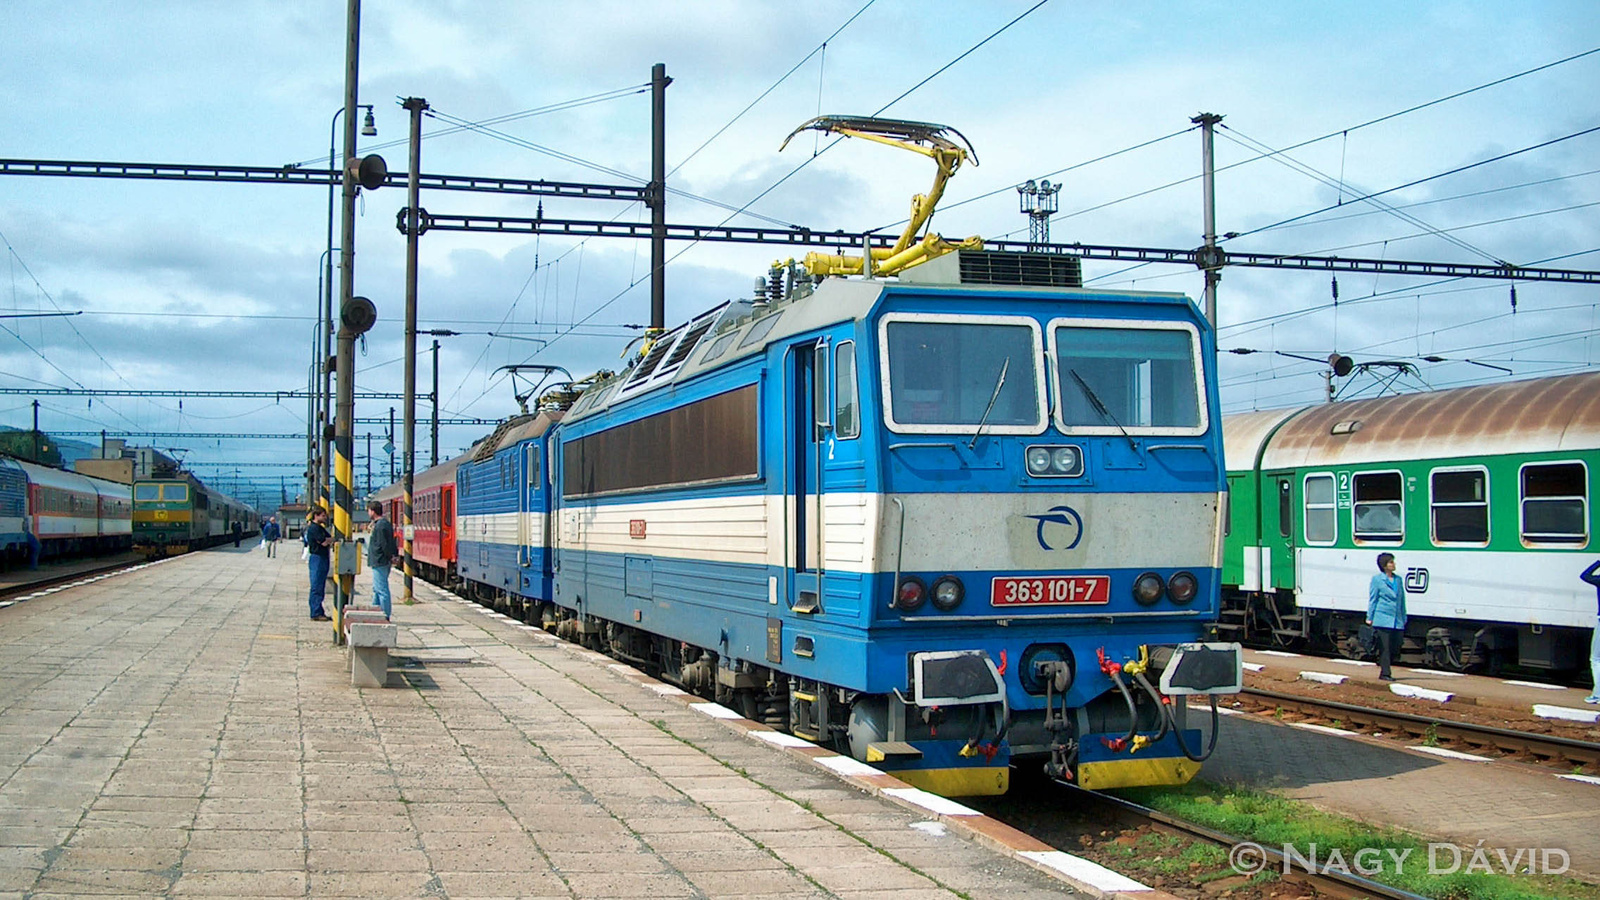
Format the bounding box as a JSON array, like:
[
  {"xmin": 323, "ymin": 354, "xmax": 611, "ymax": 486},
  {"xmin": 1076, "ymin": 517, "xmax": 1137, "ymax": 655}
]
[{"xmin": 778, "ymin": 115, "xmax": 984, "ymax": 275}]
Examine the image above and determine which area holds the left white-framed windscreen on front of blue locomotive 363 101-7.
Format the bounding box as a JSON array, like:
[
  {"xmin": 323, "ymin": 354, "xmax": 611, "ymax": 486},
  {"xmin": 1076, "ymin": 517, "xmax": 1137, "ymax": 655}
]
[{"xmin": 878, "ymin": 312, "xmax": 1045, "ymax": 434}]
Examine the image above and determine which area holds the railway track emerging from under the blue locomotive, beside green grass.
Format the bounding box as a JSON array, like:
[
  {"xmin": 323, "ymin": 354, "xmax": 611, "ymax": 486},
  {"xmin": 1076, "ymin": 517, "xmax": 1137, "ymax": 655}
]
[{"xmin": 1058, "ymin": 781, "xmax": 1427, "ymax": 900}]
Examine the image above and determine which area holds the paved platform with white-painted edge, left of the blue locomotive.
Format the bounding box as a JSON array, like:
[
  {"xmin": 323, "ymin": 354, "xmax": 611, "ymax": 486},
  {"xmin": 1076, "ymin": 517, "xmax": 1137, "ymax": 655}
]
[{"xmin": 0, "ymin": 548, "xmax": 1165, "ymax": 900}]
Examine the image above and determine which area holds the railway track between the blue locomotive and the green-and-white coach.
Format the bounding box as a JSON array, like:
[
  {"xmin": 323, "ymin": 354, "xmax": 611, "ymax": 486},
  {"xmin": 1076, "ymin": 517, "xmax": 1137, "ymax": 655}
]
[{"xmin": 1238, "ymin": 687, "xmax": 1600, "ymax": 770}]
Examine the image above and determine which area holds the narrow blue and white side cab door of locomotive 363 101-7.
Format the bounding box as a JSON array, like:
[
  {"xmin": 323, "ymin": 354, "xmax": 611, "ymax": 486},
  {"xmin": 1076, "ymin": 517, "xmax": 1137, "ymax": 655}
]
[{"xmin": 787, "ymin": 341, "xmax": 829, "ymax": 615}]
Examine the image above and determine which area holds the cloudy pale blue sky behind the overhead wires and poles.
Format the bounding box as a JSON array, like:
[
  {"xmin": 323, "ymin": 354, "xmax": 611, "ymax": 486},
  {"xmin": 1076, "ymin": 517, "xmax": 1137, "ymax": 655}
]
[{"xmin": 0, "ymin": 0, "xmax": 1600, "ymax": 500}]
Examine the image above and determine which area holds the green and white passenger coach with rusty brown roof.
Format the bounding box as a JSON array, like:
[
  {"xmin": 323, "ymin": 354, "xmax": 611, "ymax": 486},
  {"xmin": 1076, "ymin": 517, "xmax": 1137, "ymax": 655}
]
[{"xmin": 1218, "ymin": 373, "xmax": 1600, "ymax": 671}]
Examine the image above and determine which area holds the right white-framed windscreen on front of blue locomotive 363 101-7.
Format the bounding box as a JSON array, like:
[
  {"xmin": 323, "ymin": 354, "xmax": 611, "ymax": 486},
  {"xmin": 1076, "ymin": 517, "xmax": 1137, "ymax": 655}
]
[{"xmin": 1050, "ymin": 320, "xmax": 1206, "ymax": 436}]
